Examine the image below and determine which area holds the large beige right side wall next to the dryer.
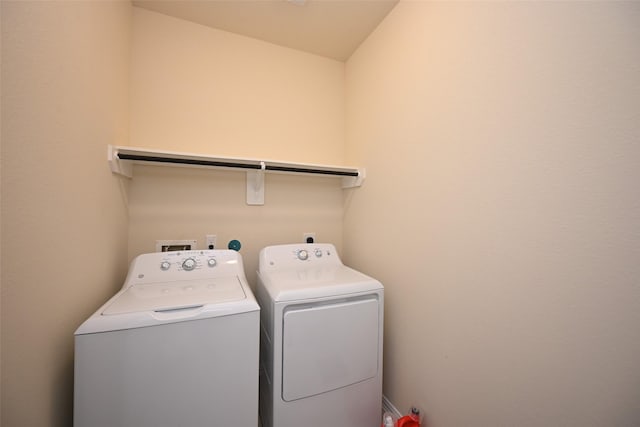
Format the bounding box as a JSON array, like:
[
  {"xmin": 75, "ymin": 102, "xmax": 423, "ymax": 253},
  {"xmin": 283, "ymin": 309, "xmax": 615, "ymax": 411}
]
[{"xmin": 344, "ymin": 2, "xmax": 640, "ymax": 427}]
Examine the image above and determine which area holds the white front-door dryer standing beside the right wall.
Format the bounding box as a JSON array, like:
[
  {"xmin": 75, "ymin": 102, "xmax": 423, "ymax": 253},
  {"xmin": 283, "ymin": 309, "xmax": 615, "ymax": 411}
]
[{"xmin": 256, "ymin": 244, "xmax": 384, "ymax": 427}]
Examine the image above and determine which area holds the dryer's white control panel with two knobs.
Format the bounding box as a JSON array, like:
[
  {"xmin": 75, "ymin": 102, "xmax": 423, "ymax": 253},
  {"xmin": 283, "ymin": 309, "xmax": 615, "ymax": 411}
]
[{"xmin": 260, "ymin": 243, "xmax": 342, "ymax": 271}]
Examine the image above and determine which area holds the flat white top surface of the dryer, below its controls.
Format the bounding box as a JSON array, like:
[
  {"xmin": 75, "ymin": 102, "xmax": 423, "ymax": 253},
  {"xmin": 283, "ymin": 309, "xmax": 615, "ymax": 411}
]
[{"xmin": 261, "ymin": 265, "xmax": 383, "ymax": 301}]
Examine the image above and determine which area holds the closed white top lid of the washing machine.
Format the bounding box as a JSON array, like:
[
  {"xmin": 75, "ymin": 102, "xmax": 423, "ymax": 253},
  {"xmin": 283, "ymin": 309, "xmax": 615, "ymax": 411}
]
[{"xmin": 102, "ymin": 276, "xmax": 247, "ymax": 315}]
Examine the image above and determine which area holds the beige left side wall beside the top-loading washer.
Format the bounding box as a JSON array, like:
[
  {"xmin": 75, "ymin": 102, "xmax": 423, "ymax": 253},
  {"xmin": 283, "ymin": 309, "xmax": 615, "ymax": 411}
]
[{"xmin": 0, "ymin": 1, "xmax": 131, "ymax": 427}]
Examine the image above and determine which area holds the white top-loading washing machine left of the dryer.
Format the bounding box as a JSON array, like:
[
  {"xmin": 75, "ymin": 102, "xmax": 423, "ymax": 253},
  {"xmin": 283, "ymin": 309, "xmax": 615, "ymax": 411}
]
[{"xmin": 74, "ymin": 250, "xmax": 260, "ymax": 427}]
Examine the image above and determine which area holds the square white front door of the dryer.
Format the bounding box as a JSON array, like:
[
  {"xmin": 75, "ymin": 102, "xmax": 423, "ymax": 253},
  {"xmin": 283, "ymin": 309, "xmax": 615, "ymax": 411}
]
[{"xmin": 282, "ymin": 294, "xmax": 380, "ymax": 402}]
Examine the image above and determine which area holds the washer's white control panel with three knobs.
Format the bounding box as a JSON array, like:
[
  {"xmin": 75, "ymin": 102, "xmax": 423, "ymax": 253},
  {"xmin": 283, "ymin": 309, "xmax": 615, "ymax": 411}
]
[{"xmin": 125, "ymin": 249, "xmax": 244, "ymax": 284}]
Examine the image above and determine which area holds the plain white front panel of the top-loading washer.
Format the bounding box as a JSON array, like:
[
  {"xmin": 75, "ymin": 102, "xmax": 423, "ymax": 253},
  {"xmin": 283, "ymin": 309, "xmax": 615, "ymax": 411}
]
[{"xmin": 73, "ymin": 311, "xmax": 259, "ymax": 427}]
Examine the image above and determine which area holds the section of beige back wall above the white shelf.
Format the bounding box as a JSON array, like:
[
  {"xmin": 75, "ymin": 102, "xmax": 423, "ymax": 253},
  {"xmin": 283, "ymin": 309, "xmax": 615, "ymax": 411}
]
[{"xmin": 131, "ymin": 8, "xmax": 344, "ymax": 164}]
